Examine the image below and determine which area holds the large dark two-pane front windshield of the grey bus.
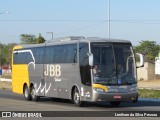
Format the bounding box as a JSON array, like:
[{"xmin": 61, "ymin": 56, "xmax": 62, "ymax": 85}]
[{"xmin": 91, "ymin": 43, "xmax": 136, "ymax": 85}]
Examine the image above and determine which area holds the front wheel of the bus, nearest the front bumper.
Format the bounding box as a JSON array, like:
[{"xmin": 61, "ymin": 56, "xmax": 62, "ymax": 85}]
[{"xmin": 72, "ymin": 87, "xmax": 84, "ymax": 107}]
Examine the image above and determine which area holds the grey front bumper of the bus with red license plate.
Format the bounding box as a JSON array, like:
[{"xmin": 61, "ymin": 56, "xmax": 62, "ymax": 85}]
[{"xmin": 91, "ymin": 91, "xmax": 138, "ymax": 102}]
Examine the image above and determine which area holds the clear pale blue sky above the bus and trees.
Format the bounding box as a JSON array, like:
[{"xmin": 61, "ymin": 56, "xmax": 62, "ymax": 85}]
[{"xmin": 0, "ymin": 0, "xmax": 160, "ymax": 45}]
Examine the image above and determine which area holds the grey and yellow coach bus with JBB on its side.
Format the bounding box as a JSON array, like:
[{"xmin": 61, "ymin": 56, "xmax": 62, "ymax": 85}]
[{"xmin": 12, "ymin": 36, "xmax": 144, "ymax": 106}]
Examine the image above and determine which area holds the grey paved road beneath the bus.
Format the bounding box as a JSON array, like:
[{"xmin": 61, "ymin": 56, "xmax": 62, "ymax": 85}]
[{"xmin": 0, "ymin": 90, "xmax": 160, "ymax": 120}]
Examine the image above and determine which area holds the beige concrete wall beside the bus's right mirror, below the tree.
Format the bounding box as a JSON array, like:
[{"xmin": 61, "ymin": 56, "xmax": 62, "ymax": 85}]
[{"xmin": 137, "ymin": 62, "xmax": 156, "ymax": 81}]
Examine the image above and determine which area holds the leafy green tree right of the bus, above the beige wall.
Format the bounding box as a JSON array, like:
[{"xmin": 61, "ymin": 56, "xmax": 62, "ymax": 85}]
[{"xmin": 134, "ymin": 40, "xmax": 159, "ymax": 63}]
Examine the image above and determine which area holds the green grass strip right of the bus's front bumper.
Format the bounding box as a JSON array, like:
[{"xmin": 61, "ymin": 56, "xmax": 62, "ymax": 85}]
[{"xmin": 138, "ymin": 89, "xmax": 160, "ymax": 98}]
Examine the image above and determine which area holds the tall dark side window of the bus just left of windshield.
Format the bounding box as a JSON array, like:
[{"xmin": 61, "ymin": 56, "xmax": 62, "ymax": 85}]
[{"xmin": 79, "ymin": 43, "xmax": 91, "ymax": 86}]
